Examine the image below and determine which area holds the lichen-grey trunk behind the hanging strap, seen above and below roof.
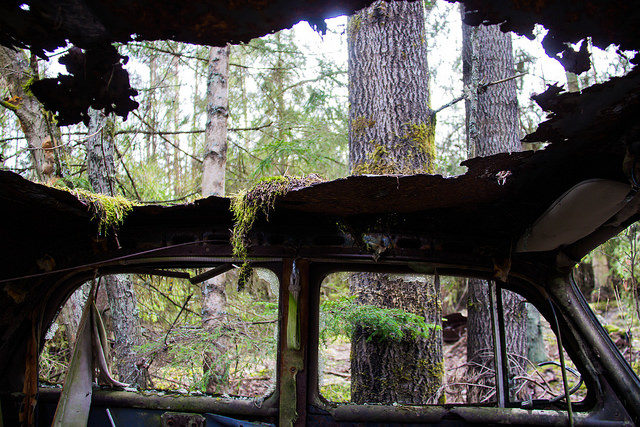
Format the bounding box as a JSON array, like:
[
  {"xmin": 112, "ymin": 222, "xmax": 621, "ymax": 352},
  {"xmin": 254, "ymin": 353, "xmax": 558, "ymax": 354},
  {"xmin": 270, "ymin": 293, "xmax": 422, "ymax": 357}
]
[{"xmin": 86, "ymin": 110, "xmax": 149, "ymax": 388}]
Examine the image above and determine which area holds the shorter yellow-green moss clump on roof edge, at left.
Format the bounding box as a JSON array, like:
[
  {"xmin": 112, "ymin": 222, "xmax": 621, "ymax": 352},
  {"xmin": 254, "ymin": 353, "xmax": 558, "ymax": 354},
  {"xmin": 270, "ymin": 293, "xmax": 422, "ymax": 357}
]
[{"xmin": 71, "ymin": 188, "xmax": 137, "ymax": 236}]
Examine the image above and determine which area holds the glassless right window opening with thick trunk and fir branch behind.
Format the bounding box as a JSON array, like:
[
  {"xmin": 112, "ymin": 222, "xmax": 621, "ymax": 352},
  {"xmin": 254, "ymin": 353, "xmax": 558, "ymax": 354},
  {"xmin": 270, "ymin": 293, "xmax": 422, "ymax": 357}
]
[{"xmin": 318, "ymin": 272, "xmax": 587, "ymax": 409}]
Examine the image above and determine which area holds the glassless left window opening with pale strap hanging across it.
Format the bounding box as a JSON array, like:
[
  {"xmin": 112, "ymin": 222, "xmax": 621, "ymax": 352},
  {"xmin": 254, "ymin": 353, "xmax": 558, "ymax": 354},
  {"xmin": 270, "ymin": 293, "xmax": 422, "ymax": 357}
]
[{"xmin": 39, "ymin": 266, "xmax": 279, "ymax": 398}]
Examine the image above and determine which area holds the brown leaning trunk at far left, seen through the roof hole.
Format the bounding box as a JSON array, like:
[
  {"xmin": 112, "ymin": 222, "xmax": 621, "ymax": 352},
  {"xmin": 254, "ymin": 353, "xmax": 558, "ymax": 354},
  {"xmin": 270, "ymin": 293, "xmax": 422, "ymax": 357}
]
[{"xmin": 0, "ymin": 46, "xmax": 60, "ymax": 182}]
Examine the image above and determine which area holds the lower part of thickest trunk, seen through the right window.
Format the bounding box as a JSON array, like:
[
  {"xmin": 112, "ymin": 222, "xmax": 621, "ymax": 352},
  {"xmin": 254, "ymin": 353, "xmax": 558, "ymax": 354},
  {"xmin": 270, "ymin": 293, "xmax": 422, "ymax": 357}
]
[{"xmin": 350, "ymin": 273, "xmax": 443, "ymax": 405}]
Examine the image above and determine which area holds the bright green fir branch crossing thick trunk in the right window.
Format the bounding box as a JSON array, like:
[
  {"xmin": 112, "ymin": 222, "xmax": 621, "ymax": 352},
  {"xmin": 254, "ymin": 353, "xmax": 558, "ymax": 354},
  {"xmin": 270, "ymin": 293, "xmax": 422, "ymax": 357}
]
[{"xmin": 320, "ymin": 295, "xmax": 440, "ymax": 341}]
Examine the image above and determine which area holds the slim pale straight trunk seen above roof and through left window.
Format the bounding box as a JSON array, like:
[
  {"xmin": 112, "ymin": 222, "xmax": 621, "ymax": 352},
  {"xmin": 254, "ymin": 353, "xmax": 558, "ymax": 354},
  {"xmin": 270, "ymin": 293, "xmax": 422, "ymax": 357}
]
[{"xmin": 202, "ymin": 45, "xmax": 230, "ymax": 393}]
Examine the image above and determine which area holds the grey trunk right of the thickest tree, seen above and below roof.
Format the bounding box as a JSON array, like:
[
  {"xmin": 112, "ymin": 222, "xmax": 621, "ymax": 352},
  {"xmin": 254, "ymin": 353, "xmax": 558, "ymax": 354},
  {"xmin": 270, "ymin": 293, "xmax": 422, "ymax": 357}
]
[{"xmin": 462, "ymin": 15, "xmax": 527, "ymax": 403}]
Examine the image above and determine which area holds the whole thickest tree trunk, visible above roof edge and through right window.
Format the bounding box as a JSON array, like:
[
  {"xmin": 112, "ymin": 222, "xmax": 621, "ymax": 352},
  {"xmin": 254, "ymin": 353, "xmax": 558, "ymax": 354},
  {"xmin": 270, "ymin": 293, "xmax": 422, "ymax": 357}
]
[{"xmin": 347, "ymin": 1, "xmax": 443, "ymax": 404}]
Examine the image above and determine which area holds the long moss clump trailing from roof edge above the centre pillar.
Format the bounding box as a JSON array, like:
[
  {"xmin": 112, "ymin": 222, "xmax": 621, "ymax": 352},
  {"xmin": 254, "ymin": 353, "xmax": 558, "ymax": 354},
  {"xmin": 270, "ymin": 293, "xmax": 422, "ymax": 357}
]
[{"xmin": 231, "ymin": 174, "xmax": 323, "ymax": 287}]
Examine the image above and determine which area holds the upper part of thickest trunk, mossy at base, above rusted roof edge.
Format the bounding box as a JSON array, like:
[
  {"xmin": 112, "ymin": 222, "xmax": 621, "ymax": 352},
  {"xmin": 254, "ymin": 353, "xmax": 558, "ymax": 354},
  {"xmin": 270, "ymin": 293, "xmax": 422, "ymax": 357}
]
[{"xmin": 347, "ymin": 1, "xmax": 435, "ymax": 174}]
